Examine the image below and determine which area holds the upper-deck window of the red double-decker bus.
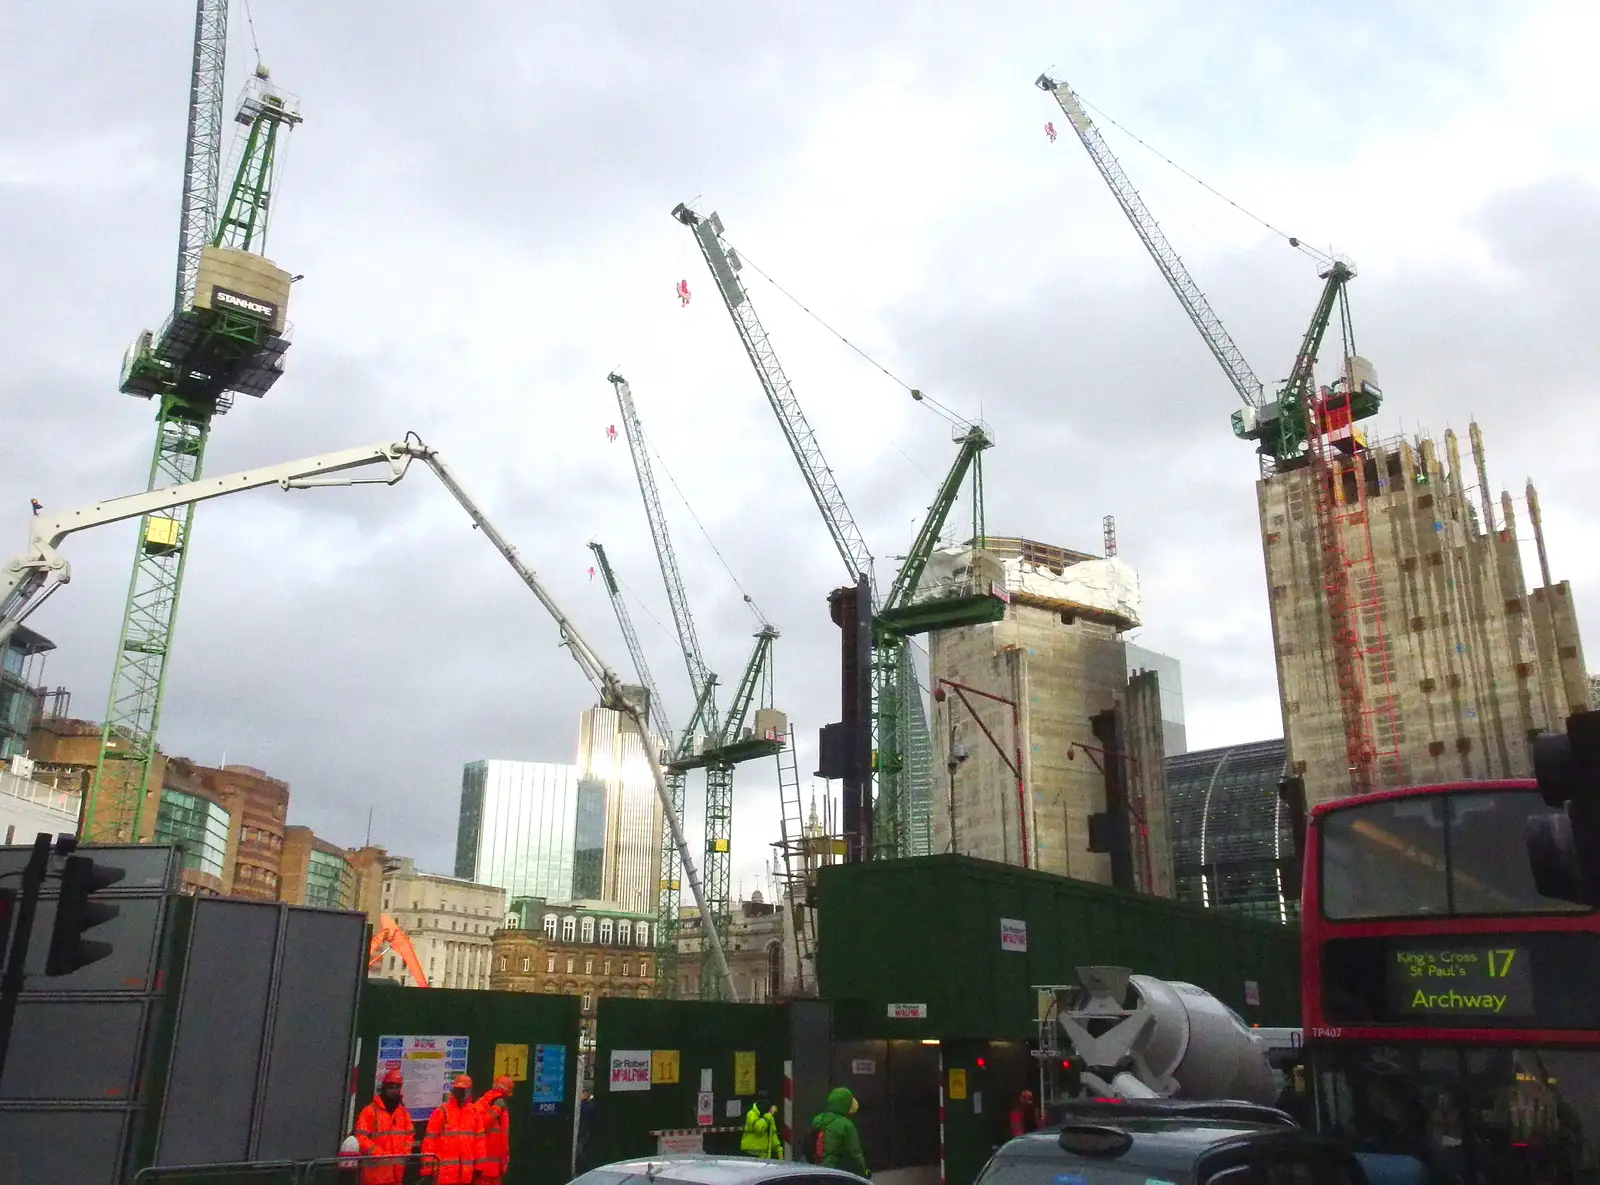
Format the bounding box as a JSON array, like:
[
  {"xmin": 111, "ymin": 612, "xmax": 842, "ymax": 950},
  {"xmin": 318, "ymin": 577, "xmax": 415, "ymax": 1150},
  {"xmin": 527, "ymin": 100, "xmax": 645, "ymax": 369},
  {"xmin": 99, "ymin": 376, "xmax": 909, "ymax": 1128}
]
[{"xmin": 1320, "ymin": 790, "xmax": 1584, "ymax": 920}]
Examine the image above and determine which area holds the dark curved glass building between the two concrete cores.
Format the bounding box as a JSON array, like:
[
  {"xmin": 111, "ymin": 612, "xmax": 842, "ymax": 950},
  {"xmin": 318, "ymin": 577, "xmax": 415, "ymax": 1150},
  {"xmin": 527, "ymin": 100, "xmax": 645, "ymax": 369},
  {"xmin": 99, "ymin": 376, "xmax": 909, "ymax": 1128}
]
[{"xmin": 1166, "ymin": 739, "xmax": 1299, "ymax": 923}]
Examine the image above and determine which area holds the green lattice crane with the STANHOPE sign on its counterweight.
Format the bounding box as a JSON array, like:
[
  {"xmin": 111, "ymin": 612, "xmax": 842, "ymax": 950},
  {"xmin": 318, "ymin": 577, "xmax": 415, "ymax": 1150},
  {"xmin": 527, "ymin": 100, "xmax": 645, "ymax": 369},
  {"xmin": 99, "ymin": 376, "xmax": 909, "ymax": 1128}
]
[{"xmin": 91, "ymin": 0, "xmax": 301, "ymax": 843}]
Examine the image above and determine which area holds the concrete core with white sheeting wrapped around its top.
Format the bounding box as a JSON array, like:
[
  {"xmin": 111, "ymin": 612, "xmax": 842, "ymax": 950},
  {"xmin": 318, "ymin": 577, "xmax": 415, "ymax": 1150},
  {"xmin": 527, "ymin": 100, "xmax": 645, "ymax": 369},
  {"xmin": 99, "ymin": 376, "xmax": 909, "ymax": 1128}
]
[{"xmin": 928, "ymin": 536, "xmax": 1176, "ymax": 896}]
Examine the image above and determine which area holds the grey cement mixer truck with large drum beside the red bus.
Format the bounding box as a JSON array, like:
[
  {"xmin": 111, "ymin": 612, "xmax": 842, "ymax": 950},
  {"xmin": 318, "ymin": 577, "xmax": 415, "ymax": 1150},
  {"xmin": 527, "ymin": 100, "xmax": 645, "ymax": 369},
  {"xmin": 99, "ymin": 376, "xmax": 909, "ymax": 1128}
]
[{"xmin": 1038, "ymin": 968, "xmax": 1299, "ymax": 1115}]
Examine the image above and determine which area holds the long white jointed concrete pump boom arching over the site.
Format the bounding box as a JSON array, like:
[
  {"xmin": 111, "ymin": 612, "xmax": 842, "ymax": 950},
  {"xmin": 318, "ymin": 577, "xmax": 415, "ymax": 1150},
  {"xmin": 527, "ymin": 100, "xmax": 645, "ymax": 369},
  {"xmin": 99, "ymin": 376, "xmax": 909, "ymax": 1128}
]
[{"xmin": 0, "ymin": 437, "xmax": 739, "ymax": 1001}]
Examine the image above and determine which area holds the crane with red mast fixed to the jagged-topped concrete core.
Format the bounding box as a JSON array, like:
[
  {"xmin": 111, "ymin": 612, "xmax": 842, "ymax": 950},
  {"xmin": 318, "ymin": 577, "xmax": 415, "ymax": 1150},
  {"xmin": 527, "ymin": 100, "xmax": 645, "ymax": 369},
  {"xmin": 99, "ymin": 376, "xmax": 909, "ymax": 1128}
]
[{"xmin": 1035, "ymin": 74, "xmax": 1398, "ymax": 793}]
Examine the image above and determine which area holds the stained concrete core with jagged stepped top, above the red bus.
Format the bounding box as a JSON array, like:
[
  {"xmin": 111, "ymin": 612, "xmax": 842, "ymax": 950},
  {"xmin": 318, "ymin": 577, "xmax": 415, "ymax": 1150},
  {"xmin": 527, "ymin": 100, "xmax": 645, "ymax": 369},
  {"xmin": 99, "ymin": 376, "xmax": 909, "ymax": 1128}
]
[{"xmin": 1256, "ymin": 424, "xmax": 1589, "ymax": 804}]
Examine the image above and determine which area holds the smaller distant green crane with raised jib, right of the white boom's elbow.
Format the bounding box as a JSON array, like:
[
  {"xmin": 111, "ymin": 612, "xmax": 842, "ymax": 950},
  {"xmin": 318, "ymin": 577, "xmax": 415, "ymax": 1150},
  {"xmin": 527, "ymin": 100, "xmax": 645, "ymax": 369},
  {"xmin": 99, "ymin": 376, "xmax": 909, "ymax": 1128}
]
[{"xmin": 606, "ymin": 373, "xmax": 781, "ymax": 982}]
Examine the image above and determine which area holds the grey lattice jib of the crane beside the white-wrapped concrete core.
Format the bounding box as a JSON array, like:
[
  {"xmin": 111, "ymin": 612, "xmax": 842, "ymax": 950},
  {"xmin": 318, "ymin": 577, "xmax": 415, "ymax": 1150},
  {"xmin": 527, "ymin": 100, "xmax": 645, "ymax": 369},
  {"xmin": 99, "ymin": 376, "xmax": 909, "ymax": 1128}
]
[{"xmin": 672, "ymin": 203, "xmax": 877, "ymax": 598}]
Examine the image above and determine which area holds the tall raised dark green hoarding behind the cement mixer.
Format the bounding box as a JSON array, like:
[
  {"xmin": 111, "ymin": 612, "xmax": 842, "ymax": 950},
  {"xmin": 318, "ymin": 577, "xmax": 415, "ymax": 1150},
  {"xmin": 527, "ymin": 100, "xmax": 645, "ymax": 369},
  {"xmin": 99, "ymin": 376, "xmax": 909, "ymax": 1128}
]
[{"xmin": 818, "ymin": 856, "xmax": 1299, "ymax": 1041}]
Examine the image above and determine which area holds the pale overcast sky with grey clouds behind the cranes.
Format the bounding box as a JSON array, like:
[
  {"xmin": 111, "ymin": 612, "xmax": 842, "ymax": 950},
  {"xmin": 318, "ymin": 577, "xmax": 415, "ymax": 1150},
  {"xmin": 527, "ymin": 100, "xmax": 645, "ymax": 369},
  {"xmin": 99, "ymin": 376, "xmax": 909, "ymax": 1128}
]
[{"xmin": 0, "ymin": 0, "xmax": 1600, "ymax": 892}]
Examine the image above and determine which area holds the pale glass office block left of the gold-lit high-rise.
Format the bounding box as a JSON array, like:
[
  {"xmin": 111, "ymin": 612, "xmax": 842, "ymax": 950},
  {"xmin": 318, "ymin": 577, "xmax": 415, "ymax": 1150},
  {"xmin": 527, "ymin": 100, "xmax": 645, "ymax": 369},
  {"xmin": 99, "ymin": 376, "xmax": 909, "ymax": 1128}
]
[{"xmin": 456, "ymin": 761, "xmax": 581, "ymax": 900}]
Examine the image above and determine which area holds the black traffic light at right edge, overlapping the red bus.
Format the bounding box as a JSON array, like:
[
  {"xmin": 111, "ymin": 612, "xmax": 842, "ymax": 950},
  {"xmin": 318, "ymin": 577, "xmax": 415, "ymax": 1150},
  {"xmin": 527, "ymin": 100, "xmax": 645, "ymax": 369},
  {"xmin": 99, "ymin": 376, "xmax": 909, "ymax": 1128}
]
[{"xmin": 1526, "ymin": 712, "xmax": 1600, "ymax": 905}]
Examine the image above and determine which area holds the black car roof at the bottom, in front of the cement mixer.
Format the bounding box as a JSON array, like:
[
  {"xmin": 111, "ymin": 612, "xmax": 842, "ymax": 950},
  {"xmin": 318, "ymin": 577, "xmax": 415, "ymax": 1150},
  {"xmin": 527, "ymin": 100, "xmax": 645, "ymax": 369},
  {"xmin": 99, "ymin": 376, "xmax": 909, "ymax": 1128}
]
[{"xmin": 974, "ymin": 1100, "xmax": 1368, "ymax": 1185}]
